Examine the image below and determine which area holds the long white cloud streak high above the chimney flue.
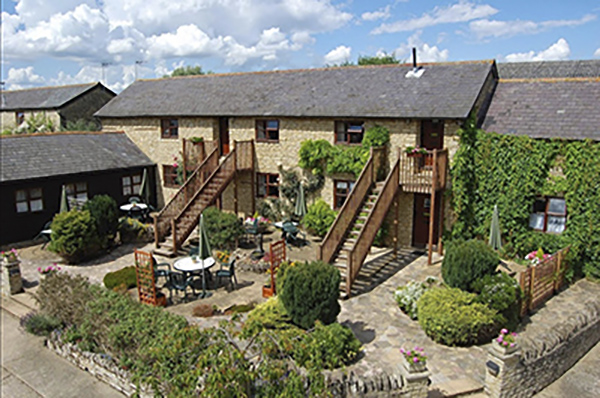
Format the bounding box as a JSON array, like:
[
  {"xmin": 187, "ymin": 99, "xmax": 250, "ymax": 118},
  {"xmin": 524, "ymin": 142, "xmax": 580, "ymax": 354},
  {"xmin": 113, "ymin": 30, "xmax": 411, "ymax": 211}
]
[{"xmin": 371, "ymin": 0, "xmax": 498, "ymax": 34}]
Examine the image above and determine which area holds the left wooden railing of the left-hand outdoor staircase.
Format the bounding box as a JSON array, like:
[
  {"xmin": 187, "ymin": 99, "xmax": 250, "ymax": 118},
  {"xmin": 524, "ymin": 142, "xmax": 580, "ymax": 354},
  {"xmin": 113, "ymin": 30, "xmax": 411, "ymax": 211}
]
[{"xmin": 154, "ymin": 145, "xmax": 219, "ymax": 248}]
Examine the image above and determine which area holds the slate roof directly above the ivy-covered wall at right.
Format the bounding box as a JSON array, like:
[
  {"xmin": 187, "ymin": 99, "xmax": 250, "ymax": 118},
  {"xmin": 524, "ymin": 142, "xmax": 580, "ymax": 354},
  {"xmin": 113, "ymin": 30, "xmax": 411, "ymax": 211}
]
[{"xmin": 483, "ymin": 78, "xmax": 600, "ymax": 141}]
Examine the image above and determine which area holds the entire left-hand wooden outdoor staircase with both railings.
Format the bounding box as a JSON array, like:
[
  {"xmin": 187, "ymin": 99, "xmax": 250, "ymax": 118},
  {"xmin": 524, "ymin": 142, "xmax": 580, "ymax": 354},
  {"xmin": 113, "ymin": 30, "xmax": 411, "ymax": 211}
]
[{"xmin": 154, "ymin": 141, "xmax": 254, "ymax": 257}]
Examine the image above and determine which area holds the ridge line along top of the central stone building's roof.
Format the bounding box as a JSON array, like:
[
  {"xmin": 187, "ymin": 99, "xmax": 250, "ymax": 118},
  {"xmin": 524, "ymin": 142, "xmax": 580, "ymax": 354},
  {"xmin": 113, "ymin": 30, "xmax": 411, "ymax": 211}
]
[{"xmin": 138, "ymin": 59, "xmax": 494, "ymax": 81}]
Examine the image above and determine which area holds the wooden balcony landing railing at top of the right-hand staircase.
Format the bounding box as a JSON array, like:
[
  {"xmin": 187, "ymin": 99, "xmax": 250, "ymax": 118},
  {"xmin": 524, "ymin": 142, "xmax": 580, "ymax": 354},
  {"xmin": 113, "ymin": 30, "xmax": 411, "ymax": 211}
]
[{"xmin": 398, "ymin": 148, "xmax": 448, "ymax": 193}]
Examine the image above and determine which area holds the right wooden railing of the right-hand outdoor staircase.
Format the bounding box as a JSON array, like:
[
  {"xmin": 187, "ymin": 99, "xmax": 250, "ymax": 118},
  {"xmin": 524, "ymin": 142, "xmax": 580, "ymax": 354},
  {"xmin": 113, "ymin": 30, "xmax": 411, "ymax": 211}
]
[{"xmin": 346, "ymin": 160, "xmax": 400, "ymax": 295}]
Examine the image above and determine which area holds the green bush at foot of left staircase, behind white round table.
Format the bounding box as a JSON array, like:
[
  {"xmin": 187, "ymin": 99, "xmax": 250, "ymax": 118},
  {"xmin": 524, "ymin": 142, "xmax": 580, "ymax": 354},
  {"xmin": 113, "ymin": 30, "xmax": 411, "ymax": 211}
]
[{"xmin": 203, "ymin": 207, "xmax": 246, "ymax": 250}]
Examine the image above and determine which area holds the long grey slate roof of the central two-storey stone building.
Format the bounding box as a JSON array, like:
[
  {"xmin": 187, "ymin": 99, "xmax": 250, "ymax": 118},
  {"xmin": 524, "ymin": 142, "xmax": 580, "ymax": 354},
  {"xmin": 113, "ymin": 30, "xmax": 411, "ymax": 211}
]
[{"xmin": 96, "ymin": 61, "xmax": 495, "ymax": 118}]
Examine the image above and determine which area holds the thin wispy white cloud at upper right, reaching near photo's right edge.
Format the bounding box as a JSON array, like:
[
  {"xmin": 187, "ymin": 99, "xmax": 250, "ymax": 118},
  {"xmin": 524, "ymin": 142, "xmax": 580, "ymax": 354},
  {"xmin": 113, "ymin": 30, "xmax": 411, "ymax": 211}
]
[{"xmin": 469, "ymin": 14, "xmax": 596, "ymax": 39}]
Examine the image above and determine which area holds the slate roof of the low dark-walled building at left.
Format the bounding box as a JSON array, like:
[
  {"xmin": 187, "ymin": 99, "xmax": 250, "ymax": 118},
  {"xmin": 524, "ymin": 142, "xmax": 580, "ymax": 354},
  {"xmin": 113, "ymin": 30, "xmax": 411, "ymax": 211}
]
[{"xmin": 0, "ymin": 133, "xmax": 154, "ymax": 182}]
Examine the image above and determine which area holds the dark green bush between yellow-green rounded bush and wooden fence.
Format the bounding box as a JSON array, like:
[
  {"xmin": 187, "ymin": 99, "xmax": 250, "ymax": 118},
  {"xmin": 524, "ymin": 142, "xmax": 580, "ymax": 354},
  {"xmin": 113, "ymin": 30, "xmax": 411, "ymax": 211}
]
[{"xmin": 473, "ymin": 272, "xmax": 522, "ymax": 330}]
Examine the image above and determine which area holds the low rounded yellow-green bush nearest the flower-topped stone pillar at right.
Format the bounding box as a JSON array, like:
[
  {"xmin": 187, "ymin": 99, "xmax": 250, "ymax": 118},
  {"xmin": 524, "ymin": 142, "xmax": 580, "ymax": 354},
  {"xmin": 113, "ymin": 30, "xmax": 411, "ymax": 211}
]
[{"xmin": 417, "ymin": 288, "xmax": 497, "ymax": 346}]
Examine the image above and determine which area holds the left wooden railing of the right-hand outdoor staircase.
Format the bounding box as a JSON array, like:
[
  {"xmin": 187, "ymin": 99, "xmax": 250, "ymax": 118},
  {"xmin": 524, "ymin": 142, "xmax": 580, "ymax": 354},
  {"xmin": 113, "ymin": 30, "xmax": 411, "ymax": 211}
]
[{"xmin": 317, "ymin": 148, "xmax": 383, "ymax": 263}]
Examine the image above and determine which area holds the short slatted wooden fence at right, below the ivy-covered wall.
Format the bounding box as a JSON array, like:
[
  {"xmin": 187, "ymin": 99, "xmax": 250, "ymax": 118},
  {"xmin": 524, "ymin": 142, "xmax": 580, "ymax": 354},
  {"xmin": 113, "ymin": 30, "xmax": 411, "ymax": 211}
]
[{"xmin": 520, "ymin": 247, "xmax": 569, "ymax": 316}]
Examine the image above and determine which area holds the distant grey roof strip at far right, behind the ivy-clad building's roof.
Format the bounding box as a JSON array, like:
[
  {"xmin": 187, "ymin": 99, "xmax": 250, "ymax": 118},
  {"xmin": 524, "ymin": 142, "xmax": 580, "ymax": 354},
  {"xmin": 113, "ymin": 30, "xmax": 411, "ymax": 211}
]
[{"xmin": 498, "ymin": 60, "xmax": 600, "ymax": 79}]
